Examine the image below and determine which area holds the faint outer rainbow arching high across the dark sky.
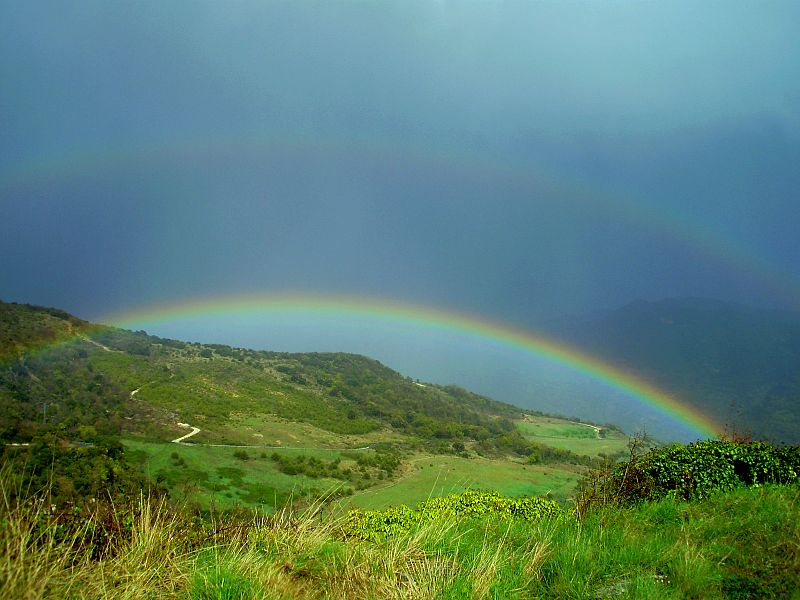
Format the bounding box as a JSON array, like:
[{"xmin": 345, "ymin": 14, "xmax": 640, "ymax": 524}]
[{"xmin": 0, "ymin": 136, "xmax": 800, "ymax": 304}]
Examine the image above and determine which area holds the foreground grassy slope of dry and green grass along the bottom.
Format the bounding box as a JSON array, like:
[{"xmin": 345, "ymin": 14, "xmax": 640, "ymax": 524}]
[{"xmin": 0, "ymin": 486, "xmax": 800, "ymax": 600}]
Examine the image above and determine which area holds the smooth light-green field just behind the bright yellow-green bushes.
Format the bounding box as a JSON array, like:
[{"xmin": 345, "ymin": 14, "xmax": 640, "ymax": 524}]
[{"xmin": 340, "ymin": 455, "xmax": 579, "ymax": 509}]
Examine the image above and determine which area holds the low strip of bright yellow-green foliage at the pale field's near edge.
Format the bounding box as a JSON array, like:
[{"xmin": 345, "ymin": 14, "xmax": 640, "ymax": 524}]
[{"xmin": 343, "ymin": 490, "xmax": 566, "ymax": 540}]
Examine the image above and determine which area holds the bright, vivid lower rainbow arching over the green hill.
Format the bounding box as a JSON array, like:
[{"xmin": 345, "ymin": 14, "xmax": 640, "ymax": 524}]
[{"xmin": 102, "ymin": 293, "xmax": 721, "ymax": 438}]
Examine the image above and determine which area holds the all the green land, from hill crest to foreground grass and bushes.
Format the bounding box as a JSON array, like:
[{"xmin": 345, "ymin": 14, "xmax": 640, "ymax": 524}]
[{"xmin": 0, "ymin": 303, "xmax": 800, "ymax": 600}]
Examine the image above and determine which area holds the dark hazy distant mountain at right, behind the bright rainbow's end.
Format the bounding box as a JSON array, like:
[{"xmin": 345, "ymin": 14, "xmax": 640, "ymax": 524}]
[{"xmin": 548, "ymin": 298, "xmax": 800, "ymax": 443}]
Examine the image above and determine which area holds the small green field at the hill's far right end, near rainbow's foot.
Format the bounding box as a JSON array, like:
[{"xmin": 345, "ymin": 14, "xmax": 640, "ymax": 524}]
[{"xmin": 515, "ymin": 417, "xmax": 628, "ymax": 456}]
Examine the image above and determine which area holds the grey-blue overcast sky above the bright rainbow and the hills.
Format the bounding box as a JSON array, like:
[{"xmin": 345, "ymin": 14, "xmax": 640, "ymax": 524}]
[{"xmin": 0, "ymin": 0, "xmax": 800, "ymax": 436}]
